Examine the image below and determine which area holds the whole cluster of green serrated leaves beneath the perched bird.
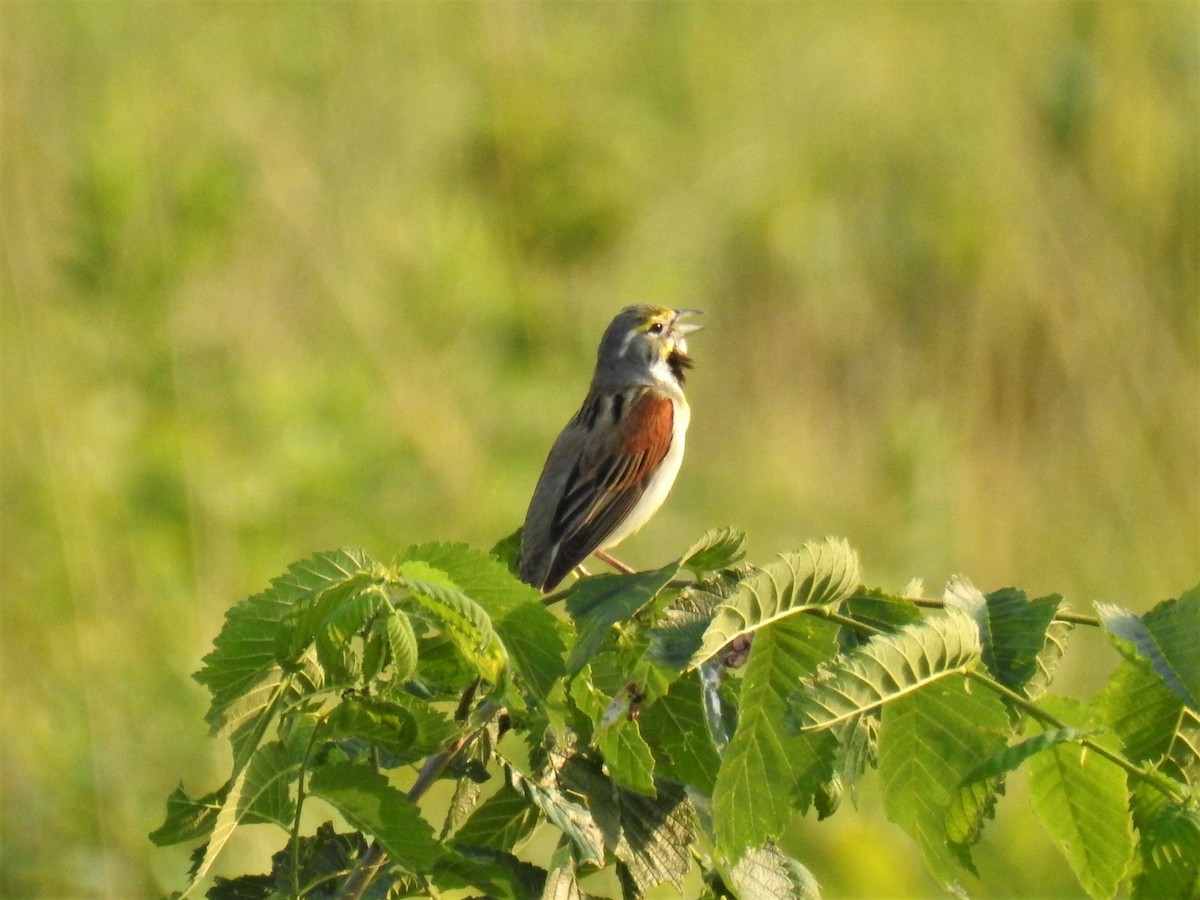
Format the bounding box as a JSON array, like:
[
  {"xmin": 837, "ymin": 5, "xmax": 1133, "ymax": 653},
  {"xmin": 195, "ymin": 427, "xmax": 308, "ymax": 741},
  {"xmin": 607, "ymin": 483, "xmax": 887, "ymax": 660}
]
[{"xmin": 151, "ymin": 529, "xmax": 1200, "ymax": 900}]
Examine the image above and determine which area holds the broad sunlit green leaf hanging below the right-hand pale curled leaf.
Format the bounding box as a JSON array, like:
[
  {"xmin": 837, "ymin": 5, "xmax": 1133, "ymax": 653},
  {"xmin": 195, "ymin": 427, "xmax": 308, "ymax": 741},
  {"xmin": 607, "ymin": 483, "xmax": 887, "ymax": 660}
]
[{"xmin": 880, "ymin": 676, "xmax": 1009, "ymax": 886}]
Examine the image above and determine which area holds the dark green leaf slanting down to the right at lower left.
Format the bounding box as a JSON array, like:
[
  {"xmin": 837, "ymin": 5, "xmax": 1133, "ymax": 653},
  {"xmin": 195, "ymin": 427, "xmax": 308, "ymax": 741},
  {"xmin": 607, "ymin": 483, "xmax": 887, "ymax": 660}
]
[{"xmin": 308, "ymin": 762, "xmax": 443, "ymax": 874}]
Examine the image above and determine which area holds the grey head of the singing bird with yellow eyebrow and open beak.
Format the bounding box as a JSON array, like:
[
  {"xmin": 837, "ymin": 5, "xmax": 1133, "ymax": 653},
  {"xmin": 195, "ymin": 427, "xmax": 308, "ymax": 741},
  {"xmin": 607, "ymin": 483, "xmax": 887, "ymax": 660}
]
[{"xmin": 596, "ymin": 305, "xmax": 703, "ymax": 385}]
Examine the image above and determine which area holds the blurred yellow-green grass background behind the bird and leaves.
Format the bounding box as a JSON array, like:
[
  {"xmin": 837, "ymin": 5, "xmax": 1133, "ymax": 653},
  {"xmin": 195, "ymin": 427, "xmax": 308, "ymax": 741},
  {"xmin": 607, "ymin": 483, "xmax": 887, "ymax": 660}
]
[{"xmin": 0, "ymin": 0, "xmax": 1200, "ymax": 898}]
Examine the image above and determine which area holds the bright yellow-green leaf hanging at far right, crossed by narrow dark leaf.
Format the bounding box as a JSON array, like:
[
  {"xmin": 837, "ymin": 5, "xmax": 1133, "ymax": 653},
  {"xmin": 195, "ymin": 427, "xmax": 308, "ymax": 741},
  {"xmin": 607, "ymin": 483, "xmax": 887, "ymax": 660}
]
[{"xmin": 1028, "ymin": 697, "xmax": 1133, "ymax": 898}]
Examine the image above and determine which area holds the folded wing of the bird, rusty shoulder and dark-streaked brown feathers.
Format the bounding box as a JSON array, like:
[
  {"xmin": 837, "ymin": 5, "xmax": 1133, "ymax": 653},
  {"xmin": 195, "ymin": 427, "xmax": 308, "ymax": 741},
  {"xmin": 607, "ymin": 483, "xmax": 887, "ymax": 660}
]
[{"xmin": 546, "ymin": 388, "xmax": 674, "ymax": 587}]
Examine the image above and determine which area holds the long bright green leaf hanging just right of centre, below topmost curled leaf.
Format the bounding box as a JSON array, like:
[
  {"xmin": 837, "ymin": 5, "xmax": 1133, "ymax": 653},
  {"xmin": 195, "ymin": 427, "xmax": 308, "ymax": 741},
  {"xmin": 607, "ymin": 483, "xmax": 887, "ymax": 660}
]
[{"xmin": 713, "ymin": 616, "xmax": 838, "ymax": 863}]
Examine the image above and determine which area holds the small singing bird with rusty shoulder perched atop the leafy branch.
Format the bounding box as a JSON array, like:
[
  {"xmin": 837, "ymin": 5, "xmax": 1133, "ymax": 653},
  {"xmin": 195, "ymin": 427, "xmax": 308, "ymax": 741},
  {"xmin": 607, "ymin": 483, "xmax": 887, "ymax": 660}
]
[{"xmin": 521, "ymin": 306, "xmax": 701, "ymax": 590}]
